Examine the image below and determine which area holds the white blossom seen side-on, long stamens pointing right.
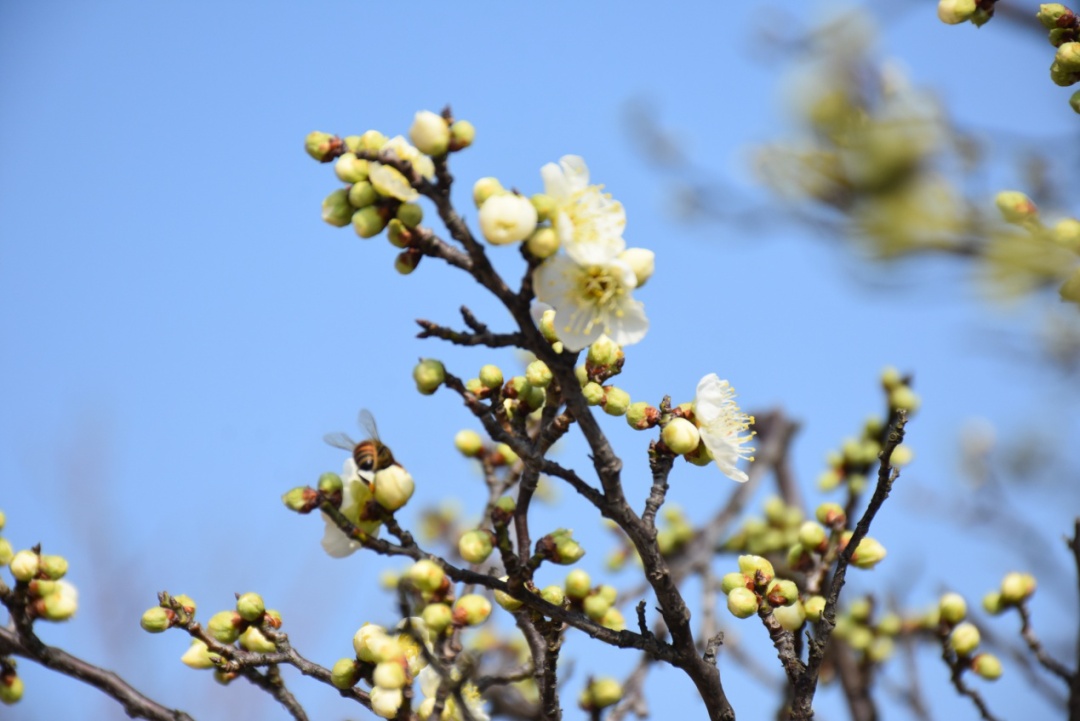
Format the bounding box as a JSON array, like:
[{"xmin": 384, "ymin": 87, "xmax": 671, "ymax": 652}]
[{"xmin": 693, "ymin": 373, "xmax": 754, "ymax": 484}]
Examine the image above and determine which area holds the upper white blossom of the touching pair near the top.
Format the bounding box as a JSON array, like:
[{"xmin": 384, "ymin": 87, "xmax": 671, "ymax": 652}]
[{"xmin": 540, "ymin": 155, "xmax": 626, "ymax": 264}]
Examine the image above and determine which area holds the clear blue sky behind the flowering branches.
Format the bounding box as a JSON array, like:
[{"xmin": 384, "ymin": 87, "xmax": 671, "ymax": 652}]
[{"xmin": 0, "ymin": 2, "xmax": 1080, "ymax": 720}]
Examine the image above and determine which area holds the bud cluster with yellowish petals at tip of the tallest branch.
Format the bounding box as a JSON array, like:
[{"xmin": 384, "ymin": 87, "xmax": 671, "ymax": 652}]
[{"xmin": 305, "ymin": 108, "xmax": 475, "ymax": 274}]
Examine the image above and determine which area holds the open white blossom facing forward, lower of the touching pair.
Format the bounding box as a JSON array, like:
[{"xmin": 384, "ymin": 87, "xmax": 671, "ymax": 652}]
[{"xmin": 534, "ymin": 256, "xmax": 649, "ymax": 351}]
